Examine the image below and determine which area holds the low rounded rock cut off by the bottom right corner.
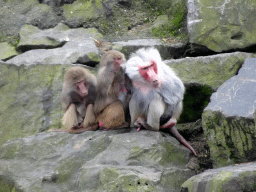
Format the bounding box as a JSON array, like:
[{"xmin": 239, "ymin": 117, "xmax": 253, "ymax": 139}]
[{"xmin": 181, "ymin": 162, "xmax": 256, "ymax": 192}]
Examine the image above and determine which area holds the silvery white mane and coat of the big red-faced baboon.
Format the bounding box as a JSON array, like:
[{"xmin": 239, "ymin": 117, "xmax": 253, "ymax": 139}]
[{"xmin": 125, "ymin": 48, "xmax": 185, "ymax": 126}]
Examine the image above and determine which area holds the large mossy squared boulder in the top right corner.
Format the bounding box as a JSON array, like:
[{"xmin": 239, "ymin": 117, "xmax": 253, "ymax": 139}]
[{"xmin": 187, "ymin": 0, "xmax": 256, "ymax": 52}]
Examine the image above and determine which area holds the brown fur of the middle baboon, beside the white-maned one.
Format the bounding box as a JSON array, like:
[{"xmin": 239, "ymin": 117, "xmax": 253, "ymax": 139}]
[{"xmin": 94, "ymin": 50, "xmax": 128, "ymax": 129}]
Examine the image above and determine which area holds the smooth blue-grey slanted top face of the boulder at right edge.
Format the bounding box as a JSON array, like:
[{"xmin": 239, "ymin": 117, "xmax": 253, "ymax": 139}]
[{"xmin": 205, "ymin": 58, "xmax": 256, "ymax": 119}]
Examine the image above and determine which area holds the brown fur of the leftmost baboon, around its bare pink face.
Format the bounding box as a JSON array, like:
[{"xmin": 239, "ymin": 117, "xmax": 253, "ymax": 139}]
[{"xmin": 51, "ymin": 67, "xmax": 97, "ymax": 133}]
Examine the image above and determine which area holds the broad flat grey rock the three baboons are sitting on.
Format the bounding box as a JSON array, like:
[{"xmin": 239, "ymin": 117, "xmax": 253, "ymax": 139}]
[{"xmin": 0, "ymin": 129, "xmax": 195, "ymax": 192}]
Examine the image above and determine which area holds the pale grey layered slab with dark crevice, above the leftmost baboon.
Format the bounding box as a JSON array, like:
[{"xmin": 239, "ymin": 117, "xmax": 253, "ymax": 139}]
[{"xmin": 7, "ymin": 23, "xmax": 102, "ymax": 67}]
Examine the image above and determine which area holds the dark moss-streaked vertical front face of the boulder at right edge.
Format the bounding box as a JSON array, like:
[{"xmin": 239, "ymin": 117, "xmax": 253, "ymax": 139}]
[{"xmin": 202, "ymin": 110, "xmax": 256, "ymax": 167}]
